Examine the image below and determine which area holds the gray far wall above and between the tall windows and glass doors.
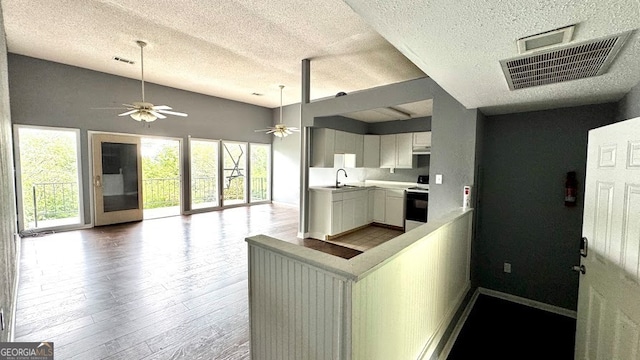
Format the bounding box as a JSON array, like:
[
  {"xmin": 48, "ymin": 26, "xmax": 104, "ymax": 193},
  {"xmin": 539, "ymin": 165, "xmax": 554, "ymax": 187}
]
[{"xmin": 9, "ymin": 54, "xmax": 274, "ymax": 223}]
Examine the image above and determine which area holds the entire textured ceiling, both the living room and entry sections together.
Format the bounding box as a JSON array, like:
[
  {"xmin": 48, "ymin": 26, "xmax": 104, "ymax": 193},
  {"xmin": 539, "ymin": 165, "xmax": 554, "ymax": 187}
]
[{"xmin": 0, "ymin": 0, "xmax": 640, "ymax": 114}]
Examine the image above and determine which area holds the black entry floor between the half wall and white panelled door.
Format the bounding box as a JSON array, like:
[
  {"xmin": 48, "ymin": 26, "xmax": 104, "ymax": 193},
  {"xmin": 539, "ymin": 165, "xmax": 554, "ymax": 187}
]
[{"xmin": 447, "ymin": 295, "xmax": 576, "ymax": 360}]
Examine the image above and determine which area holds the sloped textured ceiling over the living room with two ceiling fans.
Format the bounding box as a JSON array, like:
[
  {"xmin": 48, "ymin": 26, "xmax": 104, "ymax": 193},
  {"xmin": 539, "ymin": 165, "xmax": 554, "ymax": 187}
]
[{"xmin": 1, "ymin": 0, "xmax": 425, "ymax": 108}]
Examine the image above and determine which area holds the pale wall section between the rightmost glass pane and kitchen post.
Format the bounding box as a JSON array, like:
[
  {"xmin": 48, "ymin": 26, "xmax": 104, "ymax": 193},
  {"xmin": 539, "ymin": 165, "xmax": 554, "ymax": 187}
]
[{"xmin": 272, "ymin": 104, "xmax": 300, "ymax": 206}]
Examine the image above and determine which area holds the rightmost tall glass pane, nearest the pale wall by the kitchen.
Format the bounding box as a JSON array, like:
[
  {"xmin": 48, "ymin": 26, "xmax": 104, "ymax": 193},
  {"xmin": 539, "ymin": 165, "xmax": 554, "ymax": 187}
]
[{"xmin": 249, "ymin": 144, "xmax": 271, "ymax": 202}]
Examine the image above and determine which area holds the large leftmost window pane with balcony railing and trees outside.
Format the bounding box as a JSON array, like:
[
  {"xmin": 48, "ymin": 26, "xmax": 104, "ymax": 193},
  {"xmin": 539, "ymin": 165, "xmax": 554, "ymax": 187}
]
[{"xmin": 17, "ymin": 126, "xmax": 83, "ymax": 230}]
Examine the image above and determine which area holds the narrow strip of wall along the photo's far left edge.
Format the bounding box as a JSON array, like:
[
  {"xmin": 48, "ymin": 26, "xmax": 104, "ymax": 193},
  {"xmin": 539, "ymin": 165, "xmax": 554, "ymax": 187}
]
[{"xmin": 0, "ymin": 2, "xmax": 20, "ymax": 342}]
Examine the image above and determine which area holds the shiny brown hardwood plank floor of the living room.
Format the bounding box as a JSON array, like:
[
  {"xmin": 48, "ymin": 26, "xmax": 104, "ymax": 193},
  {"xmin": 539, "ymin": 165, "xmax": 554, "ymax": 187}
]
[{"xmin": 15, "ymin": 205, "xmax": 361, "ymax": 360}]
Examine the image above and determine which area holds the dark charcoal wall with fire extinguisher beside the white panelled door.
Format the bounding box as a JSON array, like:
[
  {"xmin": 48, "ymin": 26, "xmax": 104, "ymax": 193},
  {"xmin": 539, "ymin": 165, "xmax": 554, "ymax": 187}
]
[{"xmin": 476, "ymin": 104, "xmax": 616, "ymax": 310}]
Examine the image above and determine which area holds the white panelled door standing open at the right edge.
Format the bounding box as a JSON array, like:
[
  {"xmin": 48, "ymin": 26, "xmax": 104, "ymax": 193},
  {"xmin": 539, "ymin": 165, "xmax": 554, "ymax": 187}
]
[{"xmin": 575, "ymin": 118, "xmax": 640, "ymax": 360}]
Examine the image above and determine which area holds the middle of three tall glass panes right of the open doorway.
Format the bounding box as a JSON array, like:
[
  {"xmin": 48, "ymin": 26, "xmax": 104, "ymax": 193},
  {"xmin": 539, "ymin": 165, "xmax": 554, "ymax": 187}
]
[{"xmin": 222, "ymin": 141, "xmax": 247, "ymax": 205}]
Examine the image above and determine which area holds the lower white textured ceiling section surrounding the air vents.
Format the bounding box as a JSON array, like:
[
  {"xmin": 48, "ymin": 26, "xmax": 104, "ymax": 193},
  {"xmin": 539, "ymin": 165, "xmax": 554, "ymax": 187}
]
[{"xmin": 345, "ymin": 0, "xmax": 640, "ymax": 114}]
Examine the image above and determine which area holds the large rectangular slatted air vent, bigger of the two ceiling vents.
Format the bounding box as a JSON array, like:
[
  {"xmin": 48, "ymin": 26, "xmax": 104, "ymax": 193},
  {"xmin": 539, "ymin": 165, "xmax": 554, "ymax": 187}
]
[{"xmin": 500, "ymin": 32, "xmax": 629, "ymax": 90}]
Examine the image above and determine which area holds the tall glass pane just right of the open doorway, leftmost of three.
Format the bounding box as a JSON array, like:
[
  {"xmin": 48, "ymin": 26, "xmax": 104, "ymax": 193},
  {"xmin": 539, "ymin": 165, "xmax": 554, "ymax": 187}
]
[{"xmin": 189, "ymin": 139, "xmax": 220, "ymax": 209}]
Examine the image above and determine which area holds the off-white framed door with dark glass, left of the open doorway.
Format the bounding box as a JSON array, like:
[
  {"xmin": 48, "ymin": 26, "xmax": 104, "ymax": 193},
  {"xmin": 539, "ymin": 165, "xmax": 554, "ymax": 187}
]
[{"xmin": 92, "ymin": 134, "xmax": 143, "ymax": 226}]
